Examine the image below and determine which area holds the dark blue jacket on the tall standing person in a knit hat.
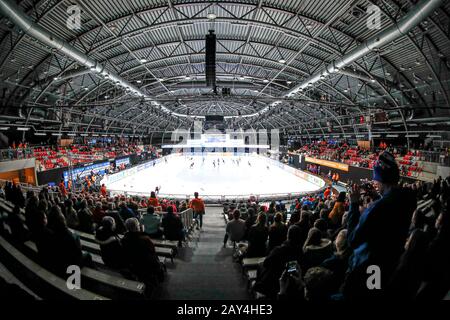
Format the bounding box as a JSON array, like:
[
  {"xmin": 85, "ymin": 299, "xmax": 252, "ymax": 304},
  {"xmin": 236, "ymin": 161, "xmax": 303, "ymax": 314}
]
[{"xmin": 344, "ymin": 188, "xmax": 417, "ymax": 298}]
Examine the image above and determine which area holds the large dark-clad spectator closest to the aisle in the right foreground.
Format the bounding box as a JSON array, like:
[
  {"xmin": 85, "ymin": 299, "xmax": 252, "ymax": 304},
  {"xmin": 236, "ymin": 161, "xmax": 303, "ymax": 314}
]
[{"xmin": 253, "ymin": 225, "xmax": 302, "ymax": 298}]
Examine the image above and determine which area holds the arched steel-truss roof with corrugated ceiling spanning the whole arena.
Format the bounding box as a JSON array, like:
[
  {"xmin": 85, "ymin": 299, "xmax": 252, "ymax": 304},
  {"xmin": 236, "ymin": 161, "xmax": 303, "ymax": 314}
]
[{"xmin": 0, "ymin": 0, "xmax": 450, "ymax": 142}]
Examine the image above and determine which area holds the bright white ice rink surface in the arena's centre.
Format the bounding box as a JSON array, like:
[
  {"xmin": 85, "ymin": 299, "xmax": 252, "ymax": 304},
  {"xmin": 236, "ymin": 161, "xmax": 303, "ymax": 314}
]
[{"xmin": 107, "ymin": 155, "xmax": 319, "ymax": 199}]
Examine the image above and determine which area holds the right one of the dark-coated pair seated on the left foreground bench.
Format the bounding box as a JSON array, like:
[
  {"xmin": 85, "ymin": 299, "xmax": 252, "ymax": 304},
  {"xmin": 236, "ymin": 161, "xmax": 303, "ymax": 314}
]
[{"xmin": 122, "ymin": 218, "xmax": 164, "ymax": 287}]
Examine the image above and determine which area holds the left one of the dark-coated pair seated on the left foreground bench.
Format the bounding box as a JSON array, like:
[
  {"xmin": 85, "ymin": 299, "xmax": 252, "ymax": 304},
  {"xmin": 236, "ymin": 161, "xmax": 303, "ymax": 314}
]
[{"xmin": 95, "ymin": 216, "xmax": 127, "ymax": 269}]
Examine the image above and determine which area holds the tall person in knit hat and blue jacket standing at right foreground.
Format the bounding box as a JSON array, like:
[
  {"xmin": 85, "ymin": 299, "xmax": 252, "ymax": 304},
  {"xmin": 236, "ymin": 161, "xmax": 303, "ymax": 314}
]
[{"xmin": 342, "ymin": 152, "xmax": 417, "ymax": 300}]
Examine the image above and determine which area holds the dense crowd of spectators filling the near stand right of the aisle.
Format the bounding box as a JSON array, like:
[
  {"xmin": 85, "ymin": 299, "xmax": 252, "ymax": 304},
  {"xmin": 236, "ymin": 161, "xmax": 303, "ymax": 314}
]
[{"xmin": 224, "ymin": 153, "xmax": 450, "ymax": 301}]
